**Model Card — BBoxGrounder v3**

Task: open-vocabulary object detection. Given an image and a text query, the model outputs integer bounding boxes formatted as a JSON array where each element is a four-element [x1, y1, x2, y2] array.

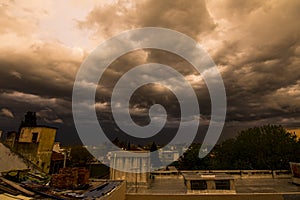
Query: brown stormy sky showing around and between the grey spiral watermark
[[0, 0, 300, 143]]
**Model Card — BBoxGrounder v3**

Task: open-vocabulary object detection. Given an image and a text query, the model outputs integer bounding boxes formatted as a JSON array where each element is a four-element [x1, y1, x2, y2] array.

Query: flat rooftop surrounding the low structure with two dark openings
[[127, 172, 300, 196]]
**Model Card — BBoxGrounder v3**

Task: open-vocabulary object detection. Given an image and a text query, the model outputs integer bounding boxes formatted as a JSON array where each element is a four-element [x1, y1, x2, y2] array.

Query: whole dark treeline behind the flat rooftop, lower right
[[172, 125, 300, 170]]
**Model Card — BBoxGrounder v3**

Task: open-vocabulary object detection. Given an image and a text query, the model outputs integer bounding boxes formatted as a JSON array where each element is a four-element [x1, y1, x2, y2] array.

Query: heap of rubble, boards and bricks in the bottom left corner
[[0, 167, 125, 200]]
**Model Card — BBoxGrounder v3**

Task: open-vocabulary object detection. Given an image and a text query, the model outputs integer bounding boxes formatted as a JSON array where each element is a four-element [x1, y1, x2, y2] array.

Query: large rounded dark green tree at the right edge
[[214, 125, 300, 170]]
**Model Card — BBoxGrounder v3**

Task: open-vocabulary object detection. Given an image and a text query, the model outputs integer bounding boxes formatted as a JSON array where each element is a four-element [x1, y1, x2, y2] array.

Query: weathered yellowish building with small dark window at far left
[[5, 126, 56, 173]]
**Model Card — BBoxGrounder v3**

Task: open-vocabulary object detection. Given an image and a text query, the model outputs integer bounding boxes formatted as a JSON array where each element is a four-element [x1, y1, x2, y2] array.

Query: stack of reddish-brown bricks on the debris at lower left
[[51, 168, 90, 189]]
